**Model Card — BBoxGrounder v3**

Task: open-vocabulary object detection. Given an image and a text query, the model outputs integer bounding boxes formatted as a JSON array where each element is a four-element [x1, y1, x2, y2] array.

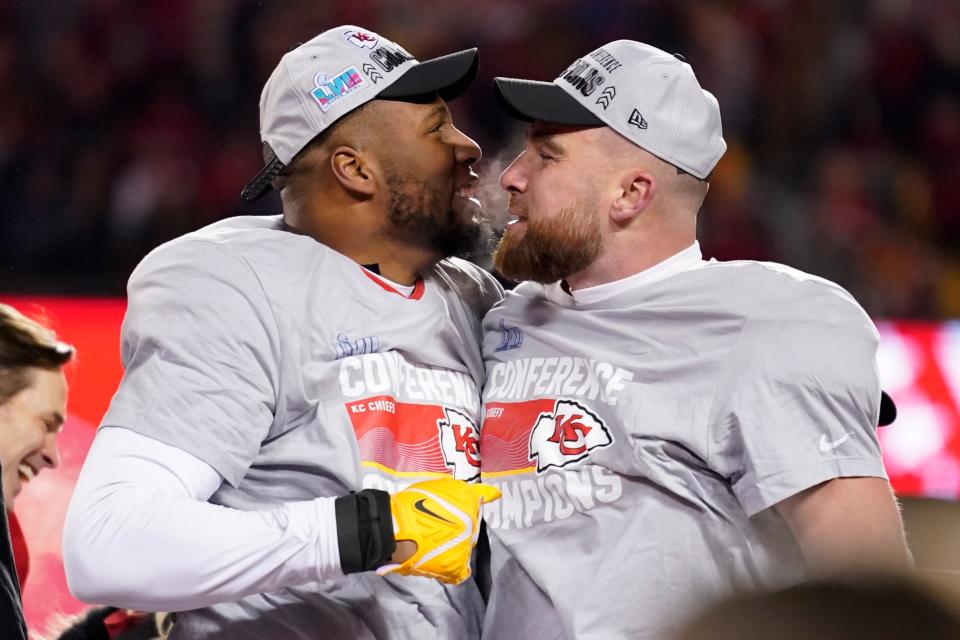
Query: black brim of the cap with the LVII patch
[[377, 48, 480, 100]]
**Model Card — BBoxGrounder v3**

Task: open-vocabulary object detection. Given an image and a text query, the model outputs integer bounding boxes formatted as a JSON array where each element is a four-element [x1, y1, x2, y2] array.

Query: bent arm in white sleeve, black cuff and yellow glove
[[63, 427, 499, 611]]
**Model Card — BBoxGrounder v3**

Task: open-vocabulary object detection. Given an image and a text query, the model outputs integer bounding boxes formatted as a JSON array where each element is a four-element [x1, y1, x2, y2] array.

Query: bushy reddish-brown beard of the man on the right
[[493, 202, 603, 284]]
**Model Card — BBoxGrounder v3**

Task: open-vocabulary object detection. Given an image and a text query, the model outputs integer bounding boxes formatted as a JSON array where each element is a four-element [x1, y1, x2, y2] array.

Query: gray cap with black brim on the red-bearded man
[[494, 40, 727, 179]]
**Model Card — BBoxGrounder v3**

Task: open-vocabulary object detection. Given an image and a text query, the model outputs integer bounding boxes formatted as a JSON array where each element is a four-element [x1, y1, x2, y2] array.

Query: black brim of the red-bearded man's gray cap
[[493, 78, 606, 127]]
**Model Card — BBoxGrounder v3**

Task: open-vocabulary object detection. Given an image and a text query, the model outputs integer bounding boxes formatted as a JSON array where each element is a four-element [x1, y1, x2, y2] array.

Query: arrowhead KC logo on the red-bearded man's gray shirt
[[530, 400, 613, 471]]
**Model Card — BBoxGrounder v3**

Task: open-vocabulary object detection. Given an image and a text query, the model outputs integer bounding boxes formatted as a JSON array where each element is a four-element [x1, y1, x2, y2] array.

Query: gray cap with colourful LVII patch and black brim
[[240, 25, 479, 201]]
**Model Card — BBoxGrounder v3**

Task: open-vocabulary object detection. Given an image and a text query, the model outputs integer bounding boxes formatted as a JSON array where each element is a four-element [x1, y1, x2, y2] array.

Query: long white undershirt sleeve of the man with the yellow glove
[[63, 427, 343, 611]]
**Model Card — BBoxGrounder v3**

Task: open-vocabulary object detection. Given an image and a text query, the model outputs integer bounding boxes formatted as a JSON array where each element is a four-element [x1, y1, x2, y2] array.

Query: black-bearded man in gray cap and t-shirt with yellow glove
[[64, 26, 502, 639]]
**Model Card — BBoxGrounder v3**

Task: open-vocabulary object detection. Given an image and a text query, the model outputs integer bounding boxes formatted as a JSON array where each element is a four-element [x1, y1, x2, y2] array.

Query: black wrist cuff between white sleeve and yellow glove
[[334, 489, 397, 573]]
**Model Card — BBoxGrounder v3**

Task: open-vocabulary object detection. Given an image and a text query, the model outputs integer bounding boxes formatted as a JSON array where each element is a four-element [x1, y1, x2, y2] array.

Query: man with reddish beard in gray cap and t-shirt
[[481, 40, 909, 639]]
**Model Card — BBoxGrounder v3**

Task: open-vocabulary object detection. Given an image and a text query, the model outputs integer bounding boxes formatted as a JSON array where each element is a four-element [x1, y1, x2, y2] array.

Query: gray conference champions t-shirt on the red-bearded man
[[481, 258, 885, 640]]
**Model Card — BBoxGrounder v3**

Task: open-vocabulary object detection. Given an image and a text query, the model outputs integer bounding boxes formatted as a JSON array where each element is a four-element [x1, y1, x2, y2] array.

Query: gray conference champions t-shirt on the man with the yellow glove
[[102, 217, 503, 640]]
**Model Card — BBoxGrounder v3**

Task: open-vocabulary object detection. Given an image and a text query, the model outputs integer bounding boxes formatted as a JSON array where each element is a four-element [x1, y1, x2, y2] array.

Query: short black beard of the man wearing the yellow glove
[[387, 173, 493, 259]]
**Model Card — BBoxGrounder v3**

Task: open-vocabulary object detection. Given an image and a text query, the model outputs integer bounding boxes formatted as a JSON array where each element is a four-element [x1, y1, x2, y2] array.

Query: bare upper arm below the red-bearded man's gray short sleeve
[[775, 477, 913, 573]]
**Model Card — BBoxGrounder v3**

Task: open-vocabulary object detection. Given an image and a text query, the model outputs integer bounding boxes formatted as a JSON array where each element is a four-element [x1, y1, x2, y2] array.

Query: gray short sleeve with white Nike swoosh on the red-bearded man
[[709, 274, 886, 516]]
